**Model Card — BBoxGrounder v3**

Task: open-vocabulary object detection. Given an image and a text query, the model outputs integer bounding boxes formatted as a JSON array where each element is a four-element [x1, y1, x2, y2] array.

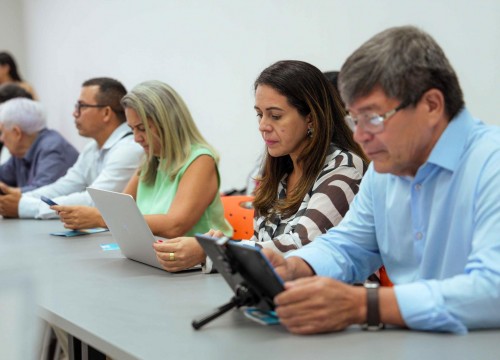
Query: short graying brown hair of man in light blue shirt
[[339, 26, 464, 119]]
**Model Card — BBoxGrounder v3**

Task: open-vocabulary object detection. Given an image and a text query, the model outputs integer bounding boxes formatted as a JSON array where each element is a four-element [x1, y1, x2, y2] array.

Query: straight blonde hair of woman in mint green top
[[121, 80, 219, 184]]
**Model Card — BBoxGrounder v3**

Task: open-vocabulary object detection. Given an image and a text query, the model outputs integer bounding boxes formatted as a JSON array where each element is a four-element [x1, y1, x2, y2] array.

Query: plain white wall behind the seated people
[[8, 0, 500, 189]]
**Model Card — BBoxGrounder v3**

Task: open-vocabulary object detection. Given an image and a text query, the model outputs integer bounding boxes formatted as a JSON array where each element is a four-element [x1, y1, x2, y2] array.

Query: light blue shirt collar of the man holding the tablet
[[427, 108, 477, 171]]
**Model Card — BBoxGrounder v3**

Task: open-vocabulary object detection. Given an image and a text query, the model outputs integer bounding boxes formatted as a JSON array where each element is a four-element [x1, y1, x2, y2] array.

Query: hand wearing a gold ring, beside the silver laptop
[[153, 237, 205, 272]]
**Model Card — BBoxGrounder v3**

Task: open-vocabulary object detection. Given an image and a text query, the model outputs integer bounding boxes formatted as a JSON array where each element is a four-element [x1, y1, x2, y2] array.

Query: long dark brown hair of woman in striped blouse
[[254, 60, 368, 217]]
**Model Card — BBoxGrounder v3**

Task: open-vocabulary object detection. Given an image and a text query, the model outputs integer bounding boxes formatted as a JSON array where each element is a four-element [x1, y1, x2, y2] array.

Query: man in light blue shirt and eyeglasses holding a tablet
[[264, 26, 500, 334]]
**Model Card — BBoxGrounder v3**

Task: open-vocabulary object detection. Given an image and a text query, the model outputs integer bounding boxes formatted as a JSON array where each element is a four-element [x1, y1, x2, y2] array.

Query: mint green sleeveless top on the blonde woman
[[136, 145, 233, 236]]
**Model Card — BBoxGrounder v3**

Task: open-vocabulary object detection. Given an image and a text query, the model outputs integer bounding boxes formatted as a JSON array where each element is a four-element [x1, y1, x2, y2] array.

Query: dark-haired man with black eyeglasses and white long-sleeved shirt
[[0, 78, 143, 219]]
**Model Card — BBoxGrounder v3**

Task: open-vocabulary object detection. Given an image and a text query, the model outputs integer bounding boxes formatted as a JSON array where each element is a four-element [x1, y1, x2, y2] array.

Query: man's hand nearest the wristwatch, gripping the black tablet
[[274, 276, 366, 334]]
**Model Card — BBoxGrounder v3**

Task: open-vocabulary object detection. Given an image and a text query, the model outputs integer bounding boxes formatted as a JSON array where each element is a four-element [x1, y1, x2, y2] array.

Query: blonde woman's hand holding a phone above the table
[[50, 205, 106, 230]]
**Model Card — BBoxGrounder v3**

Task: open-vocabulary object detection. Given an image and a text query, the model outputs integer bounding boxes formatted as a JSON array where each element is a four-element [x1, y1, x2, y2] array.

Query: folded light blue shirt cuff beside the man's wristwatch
[[394, 280, 467, 334]]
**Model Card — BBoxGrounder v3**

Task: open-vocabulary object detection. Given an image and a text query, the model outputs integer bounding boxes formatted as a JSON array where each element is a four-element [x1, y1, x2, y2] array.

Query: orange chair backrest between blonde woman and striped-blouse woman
[[221, 195, 254, 240]]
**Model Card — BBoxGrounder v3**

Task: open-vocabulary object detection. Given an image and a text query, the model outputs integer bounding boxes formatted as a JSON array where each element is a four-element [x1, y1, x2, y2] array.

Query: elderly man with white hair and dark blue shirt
[[0, 98, 78, 193]]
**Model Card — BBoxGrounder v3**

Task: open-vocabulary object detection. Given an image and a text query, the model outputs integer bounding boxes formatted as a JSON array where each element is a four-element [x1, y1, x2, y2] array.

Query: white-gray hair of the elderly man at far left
[[0, 98, 47, 135]]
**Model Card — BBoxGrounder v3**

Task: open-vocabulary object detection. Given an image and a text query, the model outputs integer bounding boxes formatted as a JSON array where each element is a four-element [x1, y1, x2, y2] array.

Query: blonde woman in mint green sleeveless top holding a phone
[[55, 81, 232, 256]]
